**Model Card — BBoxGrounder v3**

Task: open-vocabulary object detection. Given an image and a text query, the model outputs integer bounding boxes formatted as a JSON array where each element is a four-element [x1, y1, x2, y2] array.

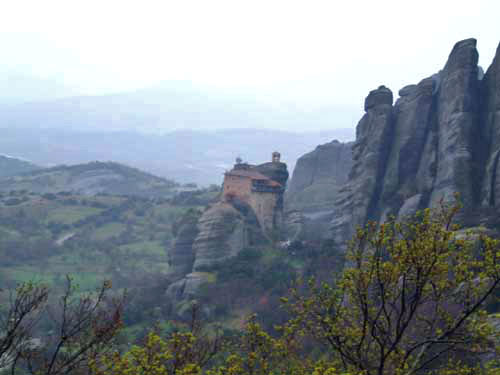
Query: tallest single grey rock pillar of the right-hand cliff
[[429, 39, 481, 210]]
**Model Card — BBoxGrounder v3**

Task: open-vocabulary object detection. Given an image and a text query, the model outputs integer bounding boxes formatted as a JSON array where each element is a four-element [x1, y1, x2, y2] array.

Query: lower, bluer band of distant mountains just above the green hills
[[0, 127, 354, 185]]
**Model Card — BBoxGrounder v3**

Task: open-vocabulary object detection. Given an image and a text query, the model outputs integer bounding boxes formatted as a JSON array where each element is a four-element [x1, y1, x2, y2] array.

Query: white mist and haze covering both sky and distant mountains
[[0, 0, 500, 184]]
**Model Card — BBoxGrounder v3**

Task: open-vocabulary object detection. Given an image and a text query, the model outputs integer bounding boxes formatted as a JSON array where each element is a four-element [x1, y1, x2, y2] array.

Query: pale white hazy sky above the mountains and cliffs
[[0, 0, 500, 108]]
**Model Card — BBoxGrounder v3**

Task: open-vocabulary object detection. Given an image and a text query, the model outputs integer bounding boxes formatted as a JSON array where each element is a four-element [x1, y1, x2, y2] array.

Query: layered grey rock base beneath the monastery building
[[166, 199, 267, 311]]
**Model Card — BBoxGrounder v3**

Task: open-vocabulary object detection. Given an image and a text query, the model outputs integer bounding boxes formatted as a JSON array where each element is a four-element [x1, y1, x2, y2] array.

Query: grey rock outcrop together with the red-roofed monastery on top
[[167, 153, 288, 313]]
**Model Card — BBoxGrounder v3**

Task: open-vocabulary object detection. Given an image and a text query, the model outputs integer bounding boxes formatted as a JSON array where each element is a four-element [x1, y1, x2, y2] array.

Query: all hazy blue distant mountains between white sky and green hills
[[0, 82, 357, 185]]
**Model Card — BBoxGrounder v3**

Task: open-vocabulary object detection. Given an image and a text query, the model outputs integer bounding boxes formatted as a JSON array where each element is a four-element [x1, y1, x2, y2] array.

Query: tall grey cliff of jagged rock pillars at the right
[[287, 39, 500, 248]]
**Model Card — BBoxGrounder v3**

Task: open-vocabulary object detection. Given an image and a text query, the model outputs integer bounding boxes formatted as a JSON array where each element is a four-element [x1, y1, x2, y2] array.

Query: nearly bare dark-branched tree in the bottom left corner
[[0, 276, 124, 375]]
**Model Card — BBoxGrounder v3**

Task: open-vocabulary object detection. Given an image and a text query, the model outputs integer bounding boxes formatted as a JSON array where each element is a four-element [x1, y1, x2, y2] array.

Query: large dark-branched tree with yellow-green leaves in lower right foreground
[[285, 204, 500, 375]]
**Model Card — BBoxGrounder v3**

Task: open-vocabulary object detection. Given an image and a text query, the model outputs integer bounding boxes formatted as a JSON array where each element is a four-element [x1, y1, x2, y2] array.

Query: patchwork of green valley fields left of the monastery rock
[[0, 192, 190, 290]]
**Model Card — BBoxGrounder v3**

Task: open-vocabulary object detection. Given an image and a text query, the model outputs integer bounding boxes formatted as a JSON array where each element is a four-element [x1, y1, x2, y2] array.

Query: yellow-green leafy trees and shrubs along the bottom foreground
[[91, 201, 500, 375]]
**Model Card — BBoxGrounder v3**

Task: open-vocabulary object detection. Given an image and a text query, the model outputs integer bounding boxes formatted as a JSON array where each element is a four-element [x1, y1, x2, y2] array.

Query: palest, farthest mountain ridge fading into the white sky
[[0, 77, 358, 132]]
